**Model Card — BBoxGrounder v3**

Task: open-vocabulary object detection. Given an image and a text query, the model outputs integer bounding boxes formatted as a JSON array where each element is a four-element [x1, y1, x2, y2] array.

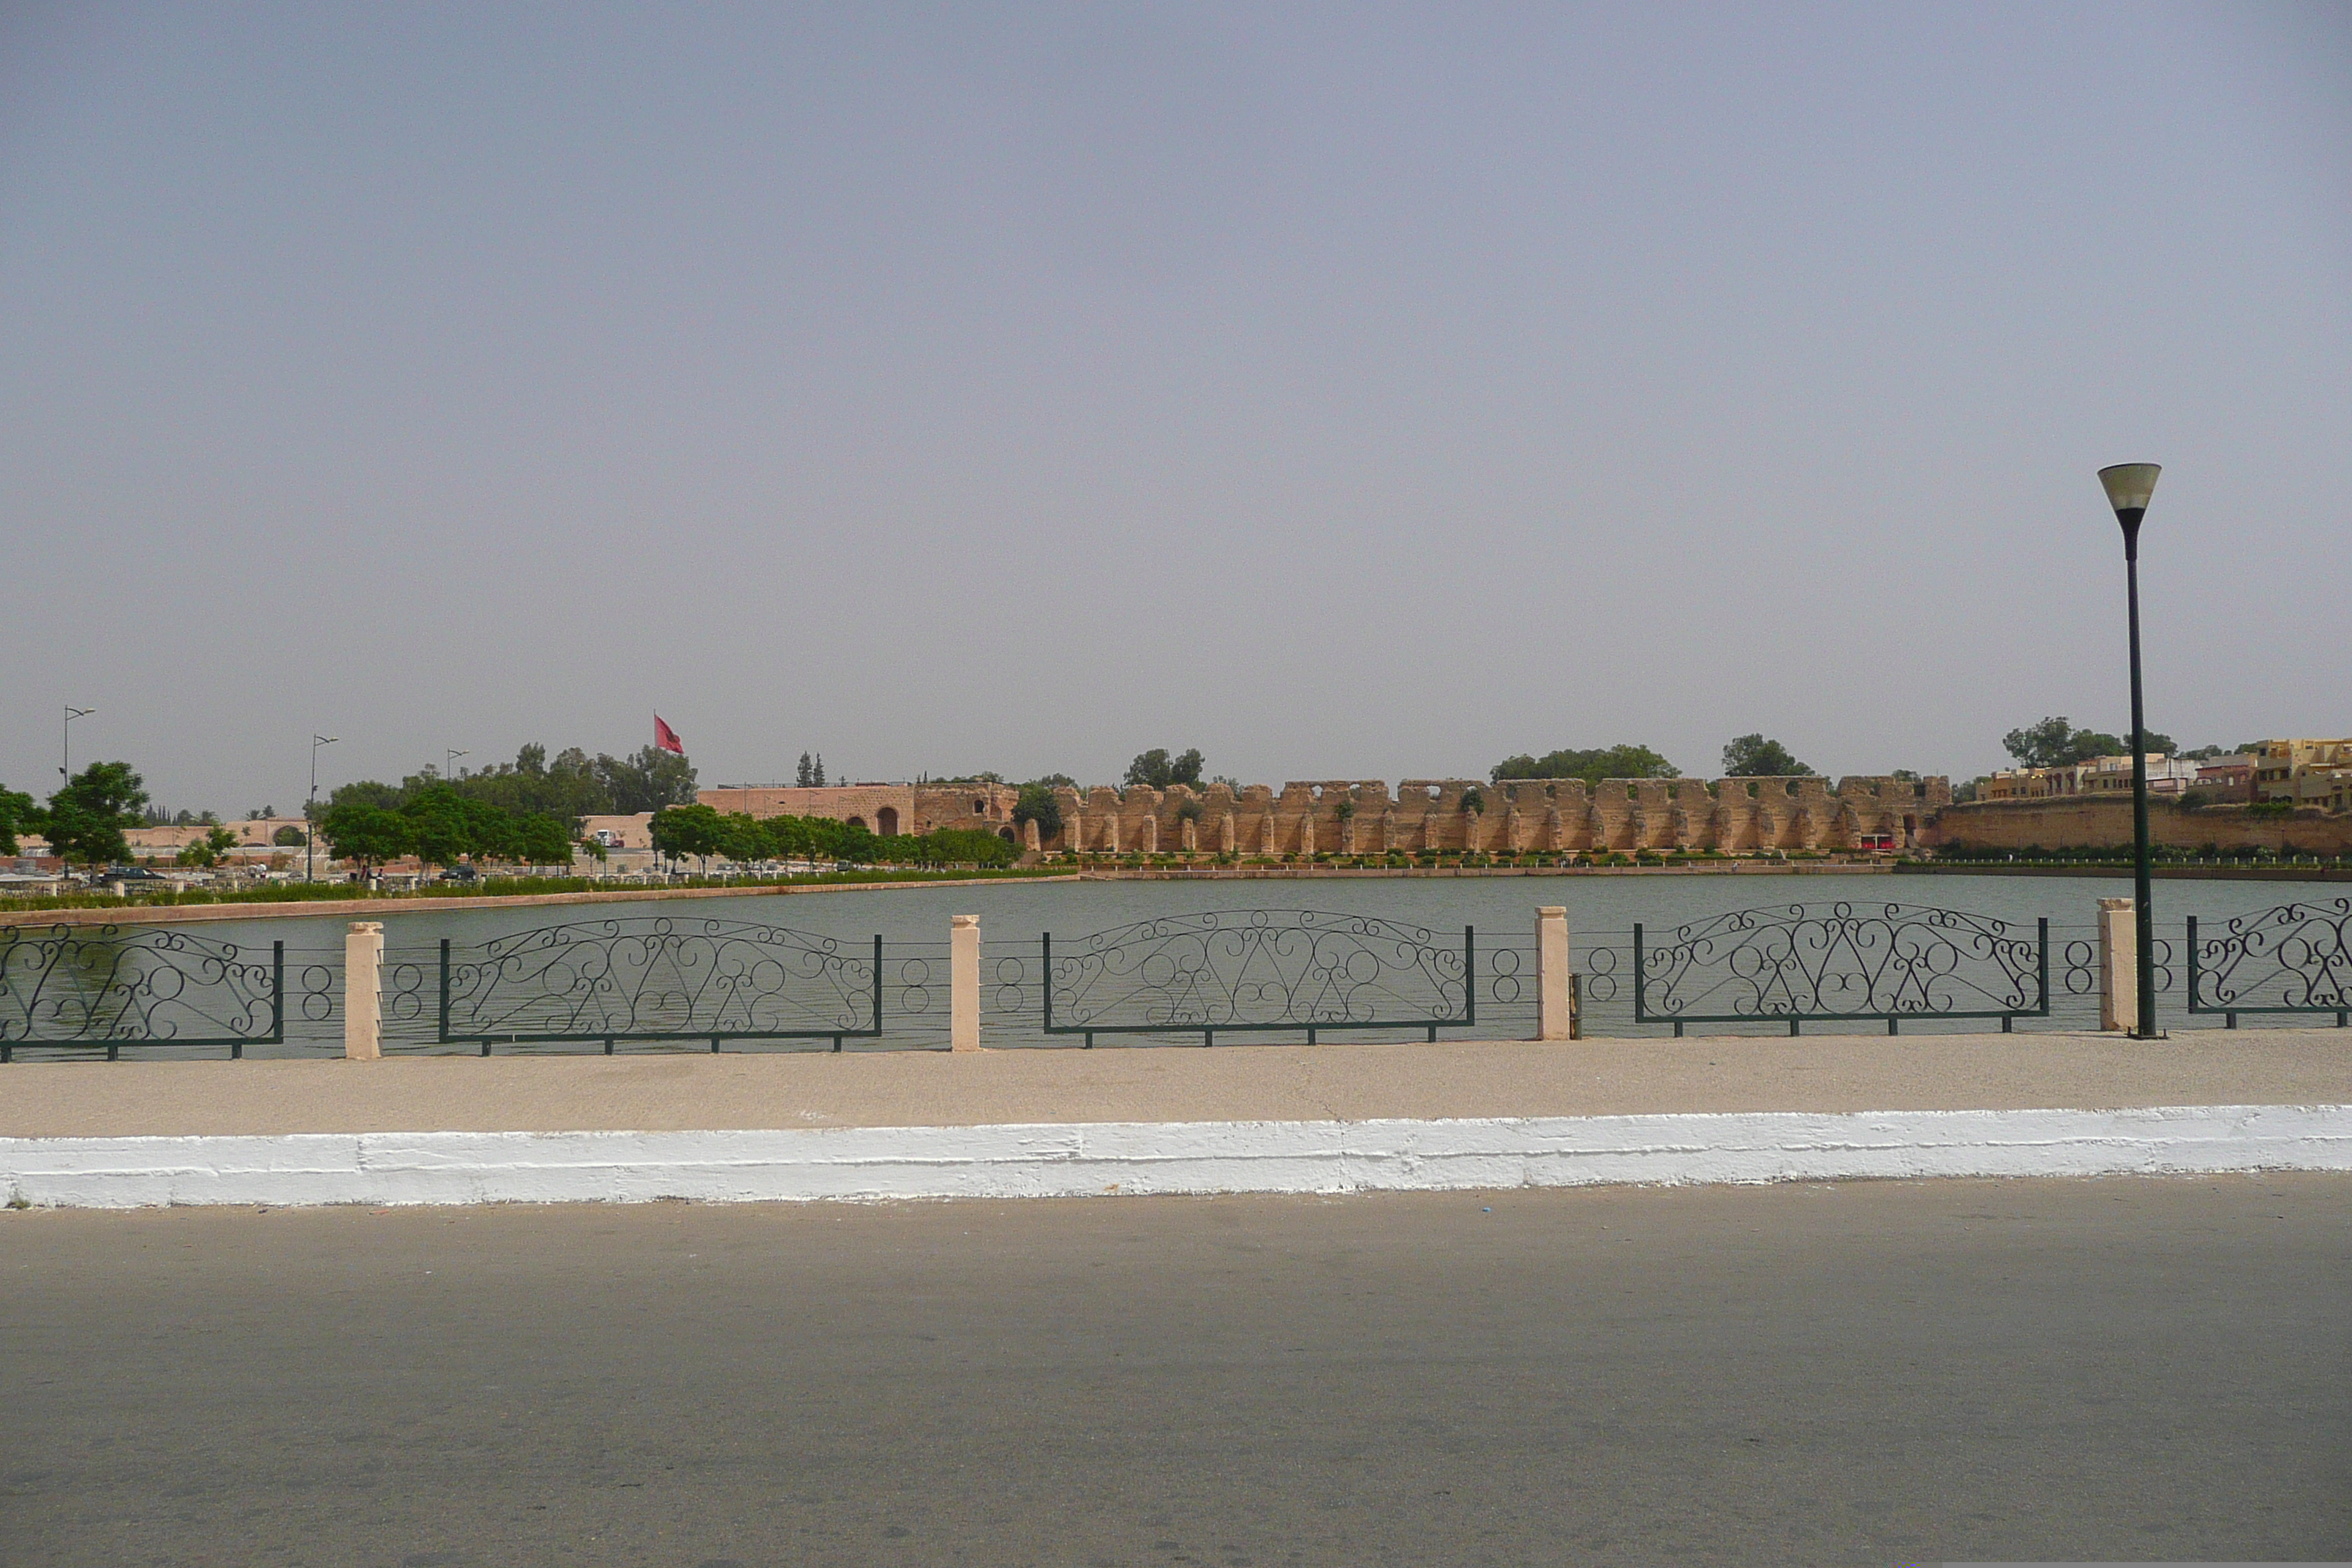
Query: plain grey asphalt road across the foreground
[[0, 1175, 2352, 1568]]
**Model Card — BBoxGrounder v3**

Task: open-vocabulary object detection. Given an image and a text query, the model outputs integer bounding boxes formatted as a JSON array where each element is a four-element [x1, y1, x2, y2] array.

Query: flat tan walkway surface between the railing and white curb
[[0, 1030, 2352, 1138]]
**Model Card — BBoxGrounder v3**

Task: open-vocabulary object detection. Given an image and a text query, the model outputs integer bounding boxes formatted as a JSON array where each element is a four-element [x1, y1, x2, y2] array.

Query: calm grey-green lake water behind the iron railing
[[19, 875, 2348, 1060]]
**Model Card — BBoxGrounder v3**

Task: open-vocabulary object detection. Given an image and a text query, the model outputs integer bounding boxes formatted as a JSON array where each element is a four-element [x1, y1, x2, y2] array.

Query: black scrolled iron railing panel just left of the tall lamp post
[[1632, 902, 2051, 1034]]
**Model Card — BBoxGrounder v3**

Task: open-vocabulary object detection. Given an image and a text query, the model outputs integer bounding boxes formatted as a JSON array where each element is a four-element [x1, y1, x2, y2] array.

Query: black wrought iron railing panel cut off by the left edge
[[0, 924, 287, 1063]]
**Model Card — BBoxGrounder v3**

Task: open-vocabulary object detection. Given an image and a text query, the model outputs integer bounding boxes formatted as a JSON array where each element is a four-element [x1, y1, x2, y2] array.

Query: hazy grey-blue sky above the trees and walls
[[0, 0, 2352, 813]]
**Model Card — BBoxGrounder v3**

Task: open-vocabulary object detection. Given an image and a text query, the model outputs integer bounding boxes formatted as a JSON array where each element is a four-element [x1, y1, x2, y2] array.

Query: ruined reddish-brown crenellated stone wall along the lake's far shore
[[1039, 778, 1952, 856]]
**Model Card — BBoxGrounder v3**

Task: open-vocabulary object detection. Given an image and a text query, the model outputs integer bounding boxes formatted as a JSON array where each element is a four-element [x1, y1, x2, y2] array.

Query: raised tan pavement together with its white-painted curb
[[0, 1030, 2352, 1206]]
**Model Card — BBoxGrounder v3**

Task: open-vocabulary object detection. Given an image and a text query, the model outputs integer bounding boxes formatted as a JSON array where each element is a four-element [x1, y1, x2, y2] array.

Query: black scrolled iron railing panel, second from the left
[[428, 917, 884, 1055]]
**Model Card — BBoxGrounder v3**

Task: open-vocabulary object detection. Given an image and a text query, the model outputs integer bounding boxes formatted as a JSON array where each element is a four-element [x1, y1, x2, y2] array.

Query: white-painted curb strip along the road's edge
[[0, 1105, 2352, 1208]]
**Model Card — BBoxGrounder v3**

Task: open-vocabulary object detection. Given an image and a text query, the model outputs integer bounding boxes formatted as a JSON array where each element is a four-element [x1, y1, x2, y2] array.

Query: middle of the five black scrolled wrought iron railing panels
[[1039, 910, 1477, 1046]]
